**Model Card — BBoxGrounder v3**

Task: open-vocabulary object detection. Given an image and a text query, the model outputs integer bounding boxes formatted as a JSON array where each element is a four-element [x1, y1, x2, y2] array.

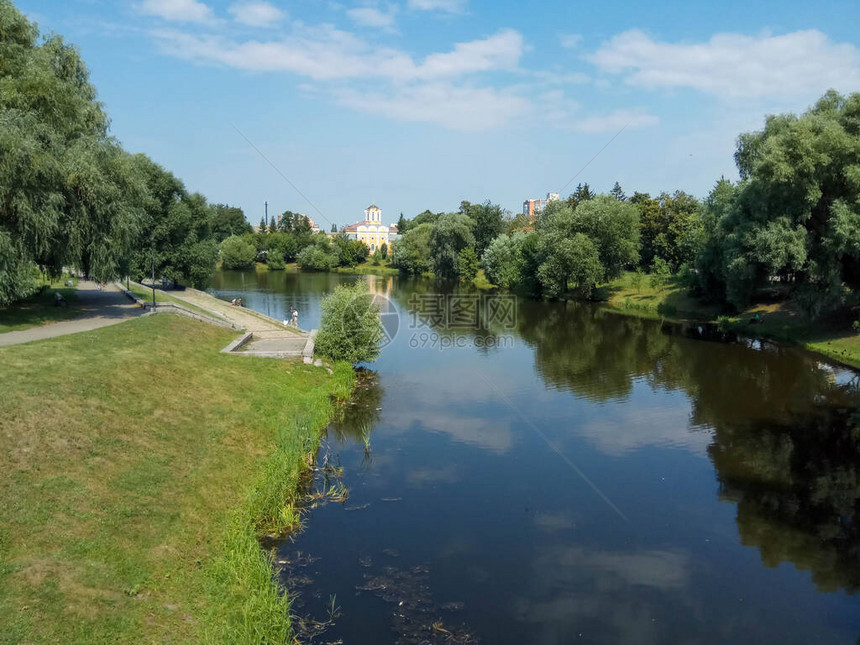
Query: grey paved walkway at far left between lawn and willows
[[0, 280, 144, 347]]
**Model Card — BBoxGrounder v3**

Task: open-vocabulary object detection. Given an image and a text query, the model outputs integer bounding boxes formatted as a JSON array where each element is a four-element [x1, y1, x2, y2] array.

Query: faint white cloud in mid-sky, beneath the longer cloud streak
[[339, 83, 529, 131]]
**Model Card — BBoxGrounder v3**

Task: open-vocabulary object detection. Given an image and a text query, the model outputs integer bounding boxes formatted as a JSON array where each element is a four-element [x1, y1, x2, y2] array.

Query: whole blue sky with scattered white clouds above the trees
[[17, 0, 860, 226]]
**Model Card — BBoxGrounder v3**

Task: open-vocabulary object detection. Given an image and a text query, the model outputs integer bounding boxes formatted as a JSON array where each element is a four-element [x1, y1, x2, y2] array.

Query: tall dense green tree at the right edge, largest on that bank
[[698, 91, 860, 315]]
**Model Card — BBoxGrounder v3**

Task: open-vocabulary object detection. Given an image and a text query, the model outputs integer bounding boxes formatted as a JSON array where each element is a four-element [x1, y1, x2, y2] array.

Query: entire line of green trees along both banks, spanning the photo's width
[[0, 0, 860, 315]]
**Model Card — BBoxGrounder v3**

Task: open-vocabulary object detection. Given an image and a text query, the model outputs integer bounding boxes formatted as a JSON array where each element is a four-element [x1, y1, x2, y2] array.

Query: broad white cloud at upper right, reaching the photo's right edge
[[590, 30, 860, 98]]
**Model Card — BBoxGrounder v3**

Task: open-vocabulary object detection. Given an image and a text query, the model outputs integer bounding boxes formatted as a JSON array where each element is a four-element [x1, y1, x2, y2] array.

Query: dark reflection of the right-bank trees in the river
[[518, 301, 860, 593]]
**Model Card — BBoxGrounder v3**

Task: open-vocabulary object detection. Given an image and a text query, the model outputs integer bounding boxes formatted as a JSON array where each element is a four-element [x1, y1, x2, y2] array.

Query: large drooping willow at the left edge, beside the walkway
[[0, 0, 146, 304]]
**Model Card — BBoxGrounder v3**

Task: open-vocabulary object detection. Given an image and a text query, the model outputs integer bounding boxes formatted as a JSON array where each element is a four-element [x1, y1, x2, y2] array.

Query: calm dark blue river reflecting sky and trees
[[213, 271, 860, 645]]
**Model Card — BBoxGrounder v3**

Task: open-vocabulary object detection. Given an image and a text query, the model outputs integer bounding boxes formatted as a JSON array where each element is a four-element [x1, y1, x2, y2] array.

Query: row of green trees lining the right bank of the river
[[456, 91, 860, 316]]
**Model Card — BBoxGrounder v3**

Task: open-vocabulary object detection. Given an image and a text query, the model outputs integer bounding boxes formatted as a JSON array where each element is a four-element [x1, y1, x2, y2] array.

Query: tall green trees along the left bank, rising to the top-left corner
[[0, 0, 250, 305]]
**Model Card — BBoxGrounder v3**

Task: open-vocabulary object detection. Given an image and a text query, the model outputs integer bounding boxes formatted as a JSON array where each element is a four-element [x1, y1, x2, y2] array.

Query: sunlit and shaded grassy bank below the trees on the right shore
[[597, 273, 860, 368]]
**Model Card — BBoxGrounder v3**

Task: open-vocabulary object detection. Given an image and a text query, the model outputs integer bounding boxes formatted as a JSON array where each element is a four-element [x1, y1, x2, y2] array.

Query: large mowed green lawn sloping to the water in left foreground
[[0, 315, 352, 645]]
